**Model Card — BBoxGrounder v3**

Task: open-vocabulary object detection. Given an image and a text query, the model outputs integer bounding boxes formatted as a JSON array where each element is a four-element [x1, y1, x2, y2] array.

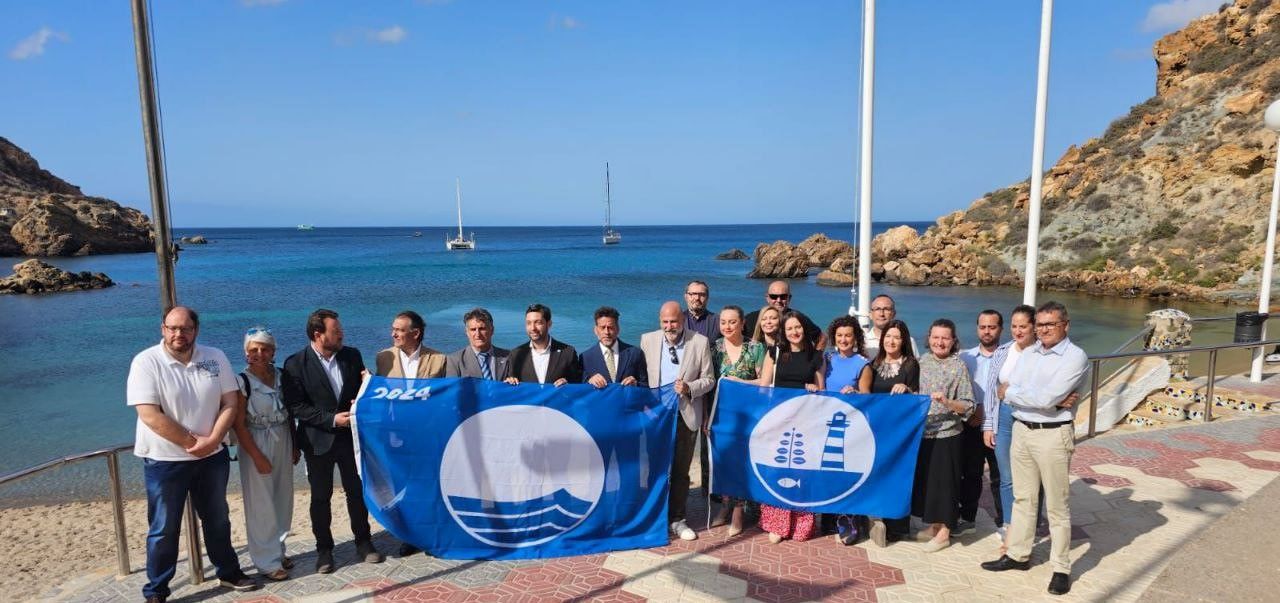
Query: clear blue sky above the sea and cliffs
[[0, 0, 1220, 227]]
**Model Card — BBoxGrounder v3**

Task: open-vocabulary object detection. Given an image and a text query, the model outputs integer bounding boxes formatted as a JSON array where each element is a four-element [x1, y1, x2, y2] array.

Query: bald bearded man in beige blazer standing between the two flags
[[640, 301, 716, 540]]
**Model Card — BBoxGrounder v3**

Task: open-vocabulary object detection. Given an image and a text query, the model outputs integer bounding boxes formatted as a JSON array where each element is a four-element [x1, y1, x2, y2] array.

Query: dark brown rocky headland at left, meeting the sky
[[0, 137, 155, 256]]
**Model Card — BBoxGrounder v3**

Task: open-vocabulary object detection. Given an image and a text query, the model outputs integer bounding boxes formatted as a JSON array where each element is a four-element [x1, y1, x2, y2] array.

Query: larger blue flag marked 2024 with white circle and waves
[[345, 376, 676, 559]]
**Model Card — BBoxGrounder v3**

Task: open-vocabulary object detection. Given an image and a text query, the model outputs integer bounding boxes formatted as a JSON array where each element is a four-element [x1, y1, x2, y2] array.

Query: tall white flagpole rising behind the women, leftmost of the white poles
[[850, 0, 876, 326]]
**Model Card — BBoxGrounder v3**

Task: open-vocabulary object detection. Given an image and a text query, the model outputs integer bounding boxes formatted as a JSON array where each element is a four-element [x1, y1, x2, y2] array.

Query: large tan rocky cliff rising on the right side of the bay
[[758, 0, 1280, 301]]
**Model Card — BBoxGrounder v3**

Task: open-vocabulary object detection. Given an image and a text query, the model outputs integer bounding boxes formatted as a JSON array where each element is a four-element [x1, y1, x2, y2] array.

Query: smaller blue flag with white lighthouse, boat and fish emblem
[[712, 380, 929, 517]]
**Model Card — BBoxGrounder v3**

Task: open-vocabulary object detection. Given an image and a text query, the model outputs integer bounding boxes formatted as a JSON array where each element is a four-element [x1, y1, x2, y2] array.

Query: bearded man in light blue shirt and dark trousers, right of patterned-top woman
[[956, 309, 1005, 534]]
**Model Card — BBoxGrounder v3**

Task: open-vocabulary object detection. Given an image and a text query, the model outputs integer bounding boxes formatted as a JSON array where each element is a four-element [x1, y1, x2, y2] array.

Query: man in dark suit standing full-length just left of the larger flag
[[280, 309, 383, 574]]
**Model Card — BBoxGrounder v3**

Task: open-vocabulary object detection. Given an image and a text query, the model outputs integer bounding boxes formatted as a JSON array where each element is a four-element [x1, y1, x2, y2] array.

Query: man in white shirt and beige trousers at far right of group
[[982, 301, 1089, 594]]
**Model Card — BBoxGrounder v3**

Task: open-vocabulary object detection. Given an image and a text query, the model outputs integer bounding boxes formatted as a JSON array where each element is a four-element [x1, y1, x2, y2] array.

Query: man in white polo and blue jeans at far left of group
[[125, 306, 257, 602]]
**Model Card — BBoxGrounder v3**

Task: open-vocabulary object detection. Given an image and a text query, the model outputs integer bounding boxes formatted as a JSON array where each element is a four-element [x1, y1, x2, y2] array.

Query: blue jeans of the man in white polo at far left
[[142, 449, 241, 598]]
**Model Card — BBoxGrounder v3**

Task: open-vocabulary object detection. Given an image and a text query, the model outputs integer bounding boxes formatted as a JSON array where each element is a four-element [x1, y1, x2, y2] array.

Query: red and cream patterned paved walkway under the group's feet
[[42, 416, 1280, 603]]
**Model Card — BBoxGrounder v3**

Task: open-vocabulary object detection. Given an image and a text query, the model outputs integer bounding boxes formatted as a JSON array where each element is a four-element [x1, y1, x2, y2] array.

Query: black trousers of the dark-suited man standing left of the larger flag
[[306, 429, 372, 551]]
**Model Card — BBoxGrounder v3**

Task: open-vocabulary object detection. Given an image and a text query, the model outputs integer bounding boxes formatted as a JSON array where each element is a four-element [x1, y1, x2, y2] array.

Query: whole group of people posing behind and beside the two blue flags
[[127, 280, 1088, 602]]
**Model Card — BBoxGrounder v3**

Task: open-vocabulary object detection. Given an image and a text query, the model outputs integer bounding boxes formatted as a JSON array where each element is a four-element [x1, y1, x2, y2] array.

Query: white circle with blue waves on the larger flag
[[440, 405, 604, 548]]
